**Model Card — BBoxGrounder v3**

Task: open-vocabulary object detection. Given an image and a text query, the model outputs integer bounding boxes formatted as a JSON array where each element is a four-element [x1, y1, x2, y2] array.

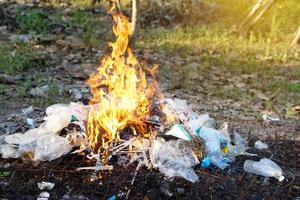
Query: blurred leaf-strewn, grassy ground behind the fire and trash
[[0, 0, 300, 120]]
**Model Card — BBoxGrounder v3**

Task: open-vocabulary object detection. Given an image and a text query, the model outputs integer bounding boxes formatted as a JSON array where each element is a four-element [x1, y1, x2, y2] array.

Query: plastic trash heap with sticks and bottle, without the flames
[[0, 98, 284, 183]]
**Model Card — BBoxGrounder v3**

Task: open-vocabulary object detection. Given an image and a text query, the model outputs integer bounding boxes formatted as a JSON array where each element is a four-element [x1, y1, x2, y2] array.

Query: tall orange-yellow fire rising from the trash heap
[[87, 9, 156, 149]]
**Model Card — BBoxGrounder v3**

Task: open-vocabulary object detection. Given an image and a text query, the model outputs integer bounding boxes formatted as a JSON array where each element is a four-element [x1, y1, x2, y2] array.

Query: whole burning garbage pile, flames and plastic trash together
[[0, 8, 284, 182]]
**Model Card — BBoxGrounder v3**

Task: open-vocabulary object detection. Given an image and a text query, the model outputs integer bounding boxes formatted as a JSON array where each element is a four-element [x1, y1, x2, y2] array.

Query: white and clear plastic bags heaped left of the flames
[[0, 103, 88, 161]]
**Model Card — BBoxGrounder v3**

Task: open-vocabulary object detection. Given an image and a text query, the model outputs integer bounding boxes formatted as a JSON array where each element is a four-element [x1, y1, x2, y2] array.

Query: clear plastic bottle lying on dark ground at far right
[[244, 158, 284, 181]]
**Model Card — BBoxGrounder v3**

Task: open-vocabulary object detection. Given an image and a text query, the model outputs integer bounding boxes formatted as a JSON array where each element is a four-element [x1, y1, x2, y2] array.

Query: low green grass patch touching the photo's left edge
[[0, 42, 39, 74]]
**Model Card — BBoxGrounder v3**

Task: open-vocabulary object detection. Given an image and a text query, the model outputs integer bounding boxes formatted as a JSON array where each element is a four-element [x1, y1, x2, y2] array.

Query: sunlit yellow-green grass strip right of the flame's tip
[[137, 24, 300, 76]]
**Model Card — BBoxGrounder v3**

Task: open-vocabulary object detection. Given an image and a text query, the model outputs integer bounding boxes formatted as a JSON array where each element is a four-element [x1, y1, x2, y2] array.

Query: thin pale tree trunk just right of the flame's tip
[[129, 0, 140, 47]]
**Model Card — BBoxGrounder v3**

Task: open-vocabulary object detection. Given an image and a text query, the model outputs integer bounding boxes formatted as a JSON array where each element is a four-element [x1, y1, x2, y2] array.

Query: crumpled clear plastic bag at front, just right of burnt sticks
[[149, 139, 199, 183]]
